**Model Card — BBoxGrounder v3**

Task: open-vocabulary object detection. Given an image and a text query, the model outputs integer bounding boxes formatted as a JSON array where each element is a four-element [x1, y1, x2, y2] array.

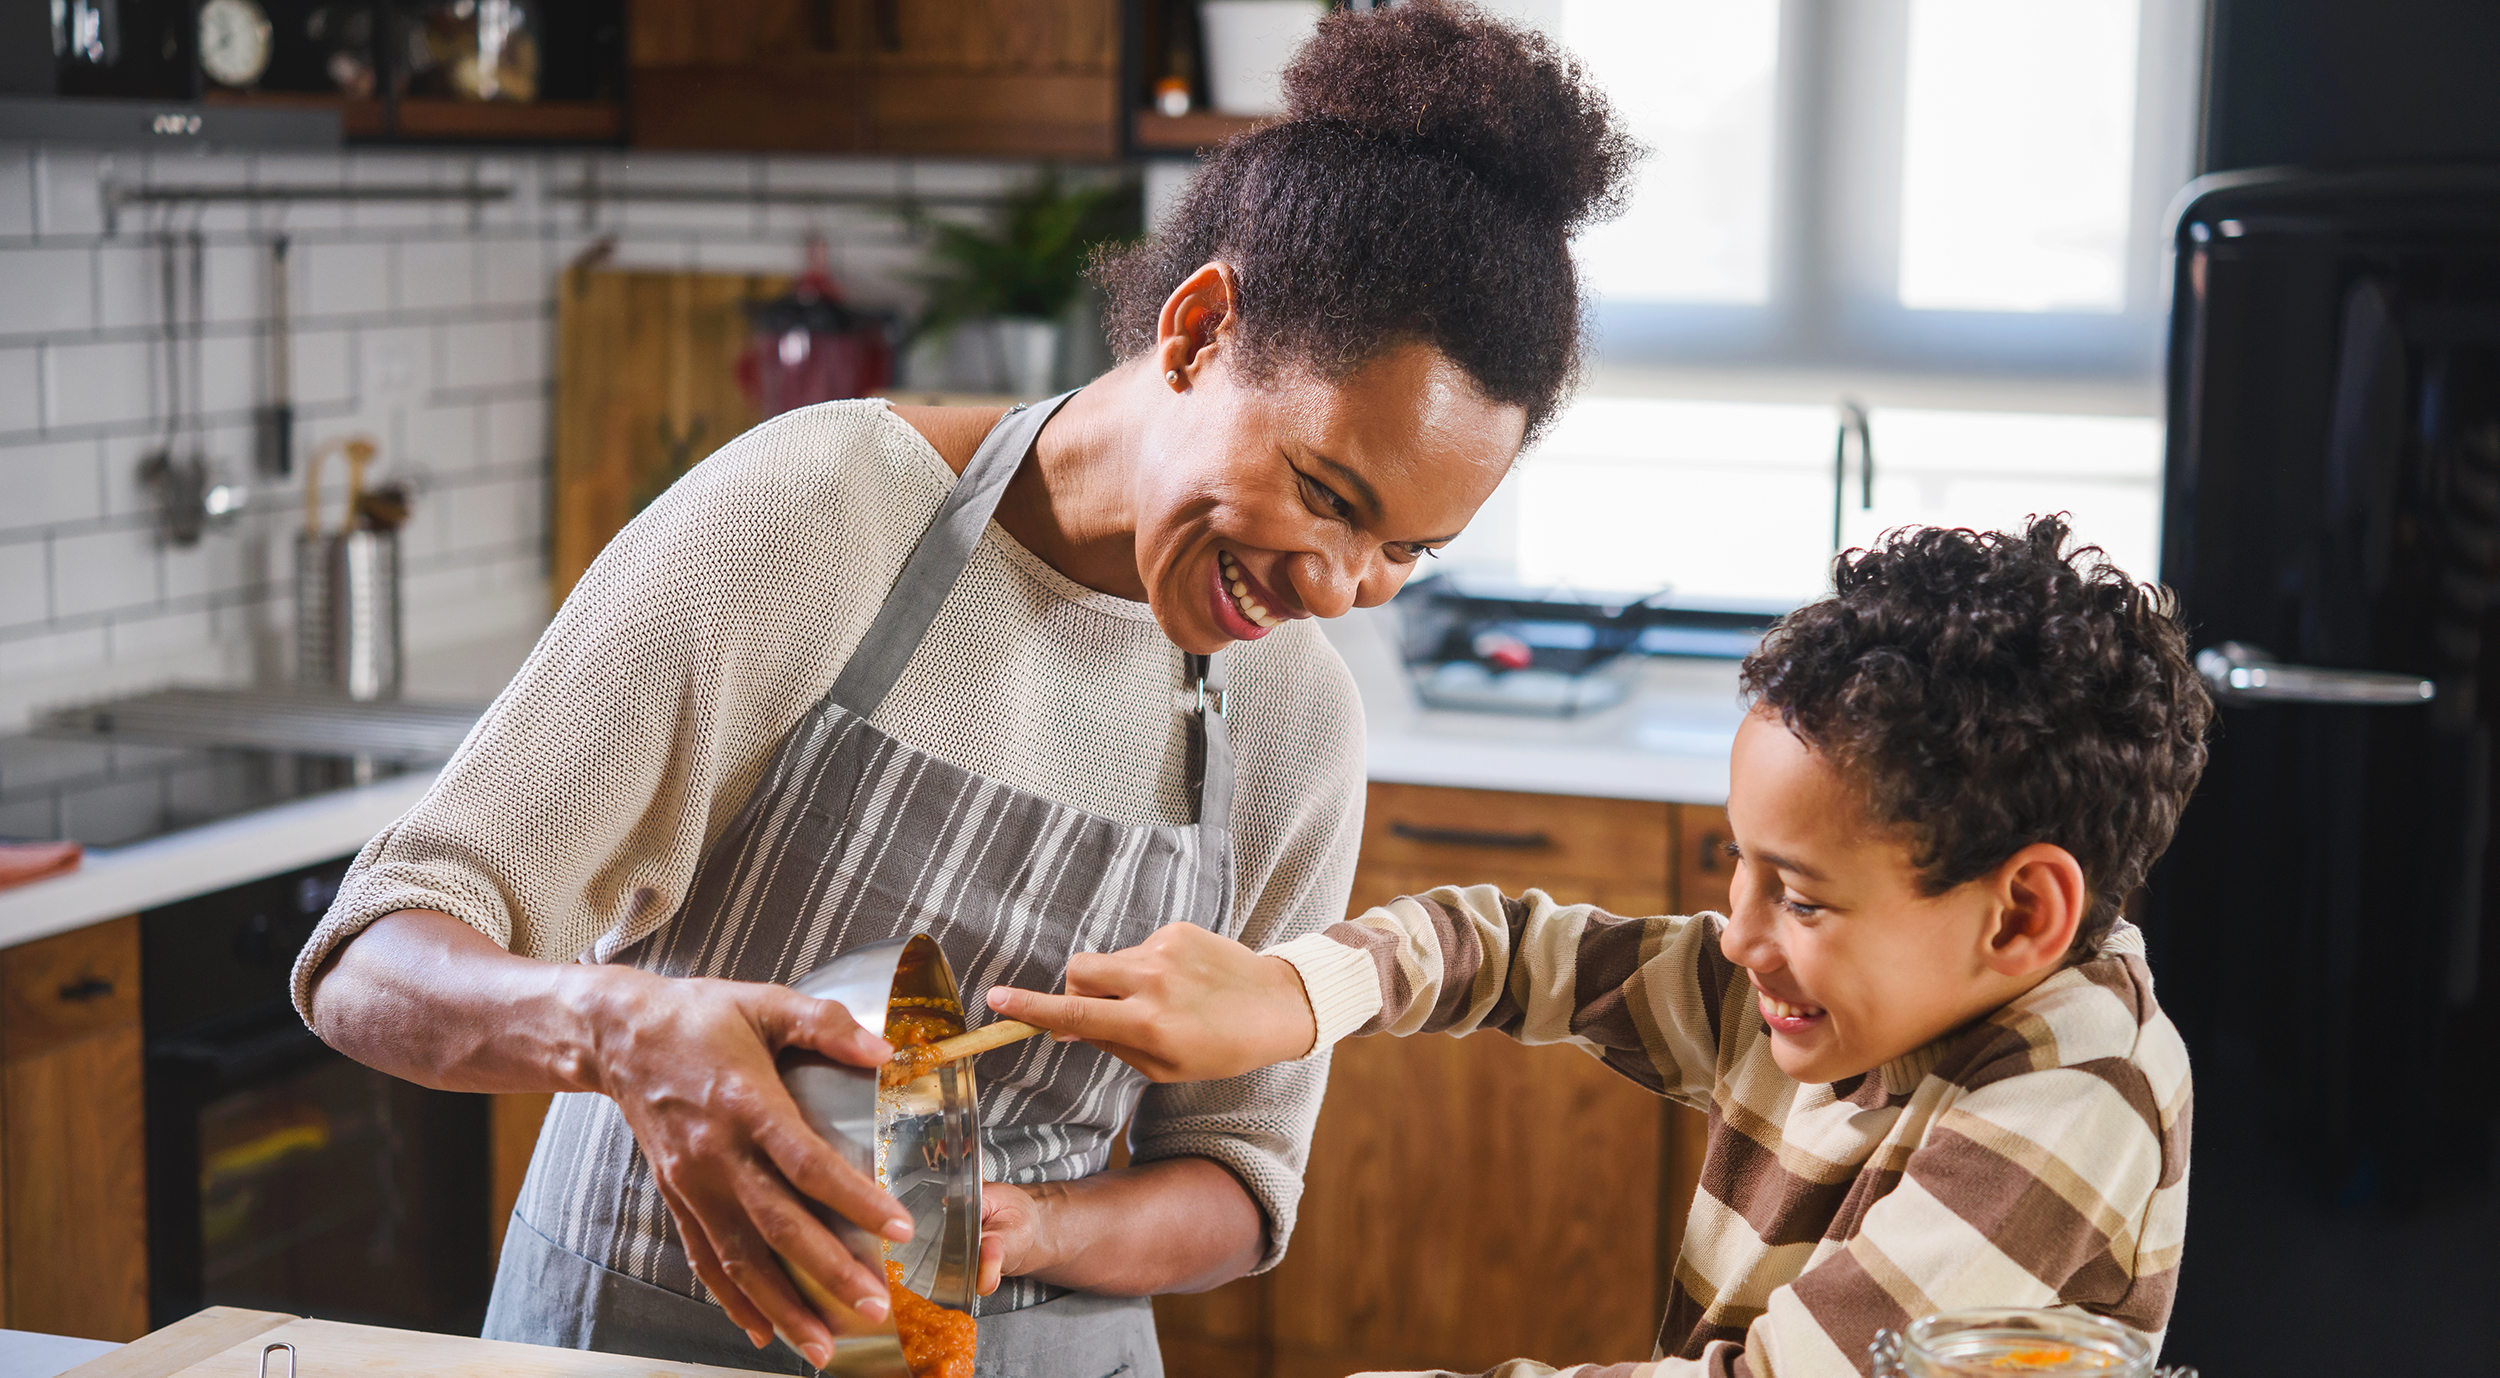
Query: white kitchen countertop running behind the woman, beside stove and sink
[[0, 610, 1743, 948]]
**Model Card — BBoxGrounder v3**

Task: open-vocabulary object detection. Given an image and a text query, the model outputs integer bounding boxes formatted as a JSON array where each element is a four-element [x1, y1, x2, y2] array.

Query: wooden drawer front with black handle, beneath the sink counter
[[1363, 783, 1673, 890]]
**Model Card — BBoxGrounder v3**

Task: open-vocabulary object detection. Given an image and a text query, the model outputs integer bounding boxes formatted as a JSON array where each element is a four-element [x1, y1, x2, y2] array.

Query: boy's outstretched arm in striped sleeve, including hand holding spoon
[[990, 885, 1735, 1100]]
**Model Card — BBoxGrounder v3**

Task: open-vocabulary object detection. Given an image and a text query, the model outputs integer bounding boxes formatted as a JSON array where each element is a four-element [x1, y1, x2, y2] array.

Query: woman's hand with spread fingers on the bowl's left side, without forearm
[[590, 968, 913, 1368]]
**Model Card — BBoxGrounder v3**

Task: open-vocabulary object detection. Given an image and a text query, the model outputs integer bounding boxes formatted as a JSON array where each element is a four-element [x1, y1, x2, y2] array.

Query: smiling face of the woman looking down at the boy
[[1133, 345, 1528, 655]]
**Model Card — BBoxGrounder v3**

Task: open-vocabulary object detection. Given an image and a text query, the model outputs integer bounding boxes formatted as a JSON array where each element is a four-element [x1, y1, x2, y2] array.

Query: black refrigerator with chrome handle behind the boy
[[2143, 168, 2500, 1378]]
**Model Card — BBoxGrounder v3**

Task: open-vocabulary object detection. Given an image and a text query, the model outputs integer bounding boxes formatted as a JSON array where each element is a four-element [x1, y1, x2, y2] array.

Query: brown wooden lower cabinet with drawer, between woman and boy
[[1155, 783, 1728, 1378]]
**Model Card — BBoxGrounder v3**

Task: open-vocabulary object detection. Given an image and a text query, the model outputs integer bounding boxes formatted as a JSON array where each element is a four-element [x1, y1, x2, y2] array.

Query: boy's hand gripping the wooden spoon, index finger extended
[[990, 923, 1320, 1080]]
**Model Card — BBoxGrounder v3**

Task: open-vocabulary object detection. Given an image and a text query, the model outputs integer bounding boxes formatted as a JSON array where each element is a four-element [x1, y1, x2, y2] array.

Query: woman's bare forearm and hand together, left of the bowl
[[310, 910, 910, 1368]]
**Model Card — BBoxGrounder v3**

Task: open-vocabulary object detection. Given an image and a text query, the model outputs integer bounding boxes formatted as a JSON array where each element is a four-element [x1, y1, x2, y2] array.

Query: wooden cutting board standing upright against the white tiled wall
[[550, 265, 790, 603]]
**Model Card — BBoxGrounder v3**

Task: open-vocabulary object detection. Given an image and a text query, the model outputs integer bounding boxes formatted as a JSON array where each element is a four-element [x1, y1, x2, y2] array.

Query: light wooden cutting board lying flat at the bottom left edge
[[63, 1305, 780, 1378]]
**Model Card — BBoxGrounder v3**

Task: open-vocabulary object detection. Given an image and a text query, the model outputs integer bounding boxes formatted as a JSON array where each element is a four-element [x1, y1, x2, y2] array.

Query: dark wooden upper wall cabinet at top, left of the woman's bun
[[628, 0, 1120, 160]]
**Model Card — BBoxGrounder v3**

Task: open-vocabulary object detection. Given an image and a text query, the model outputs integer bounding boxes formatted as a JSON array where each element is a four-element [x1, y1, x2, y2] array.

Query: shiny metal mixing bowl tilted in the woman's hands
[[780, 933, 980, 1378]]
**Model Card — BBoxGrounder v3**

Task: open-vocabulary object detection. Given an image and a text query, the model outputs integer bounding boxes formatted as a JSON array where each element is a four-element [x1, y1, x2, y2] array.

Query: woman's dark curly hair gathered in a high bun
[[1093, 0, 1640, 438]]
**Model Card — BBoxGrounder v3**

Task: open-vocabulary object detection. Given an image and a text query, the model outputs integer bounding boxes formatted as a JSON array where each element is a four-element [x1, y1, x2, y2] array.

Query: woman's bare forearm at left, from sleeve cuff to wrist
[[310, 910, 625, 1090]]
